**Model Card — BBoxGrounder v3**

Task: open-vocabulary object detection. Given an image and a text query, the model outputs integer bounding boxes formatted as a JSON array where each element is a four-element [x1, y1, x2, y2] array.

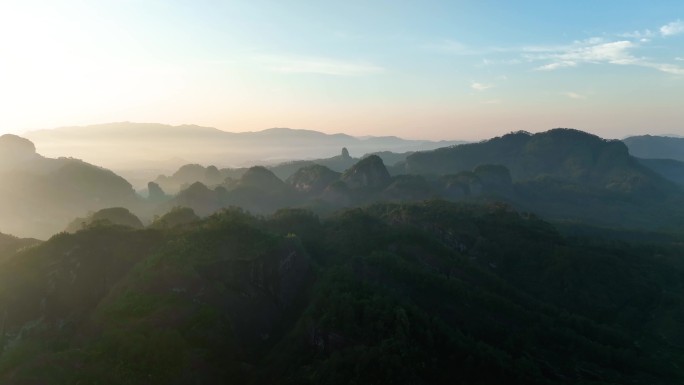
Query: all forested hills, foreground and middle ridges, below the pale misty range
[[0, 129, 684, 385]]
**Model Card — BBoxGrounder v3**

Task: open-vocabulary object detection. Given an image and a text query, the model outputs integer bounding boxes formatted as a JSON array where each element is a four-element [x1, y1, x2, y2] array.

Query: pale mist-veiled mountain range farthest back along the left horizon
[[25, 122, 462, 183]]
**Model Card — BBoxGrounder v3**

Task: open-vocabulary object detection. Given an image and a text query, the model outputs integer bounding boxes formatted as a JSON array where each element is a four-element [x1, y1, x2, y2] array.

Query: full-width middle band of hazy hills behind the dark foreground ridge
[[5, 129, 684, 238]]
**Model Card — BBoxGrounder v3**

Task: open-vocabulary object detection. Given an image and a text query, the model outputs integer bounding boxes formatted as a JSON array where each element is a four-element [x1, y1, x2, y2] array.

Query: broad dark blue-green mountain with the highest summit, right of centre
[[405, 129, 672, 191]]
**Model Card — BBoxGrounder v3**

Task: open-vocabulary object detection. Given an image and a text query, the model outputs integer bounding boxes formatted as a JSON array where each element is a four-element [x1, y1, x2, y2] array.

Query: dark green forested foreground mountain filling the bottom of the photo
[[0, 201, 684, 385]]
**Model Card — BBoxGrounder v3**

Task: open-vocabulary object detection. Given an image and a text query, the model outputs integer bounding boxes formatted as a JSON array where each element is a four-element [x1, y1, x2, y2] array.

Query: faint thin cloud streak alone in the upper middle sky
[[254, 55, 385, 76]]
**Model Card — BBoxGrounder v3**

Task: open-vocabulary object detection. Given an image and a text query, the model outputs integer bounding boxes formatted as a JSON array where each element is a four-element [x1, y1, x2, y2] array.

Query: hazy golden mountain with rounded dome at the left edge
[[0, 135, 139, 238]]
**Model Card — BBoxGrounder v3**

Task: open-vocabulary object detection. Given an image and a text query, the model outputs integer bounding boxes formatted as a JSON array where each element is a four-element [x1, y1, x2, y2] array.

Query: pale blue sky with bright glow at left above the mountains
[[0, 0, 684, 140]]
